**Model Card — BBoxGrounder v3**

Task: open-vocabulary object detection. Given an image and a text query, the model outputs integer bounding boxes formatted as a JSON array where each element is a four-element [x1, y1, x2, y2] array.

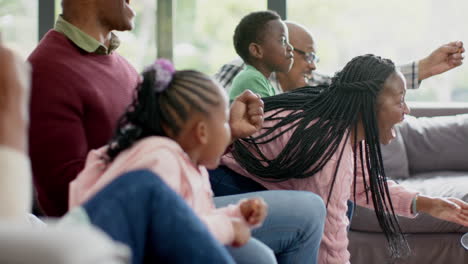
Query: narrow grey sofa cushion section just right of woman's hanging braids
[[381, 125, 409, 179]]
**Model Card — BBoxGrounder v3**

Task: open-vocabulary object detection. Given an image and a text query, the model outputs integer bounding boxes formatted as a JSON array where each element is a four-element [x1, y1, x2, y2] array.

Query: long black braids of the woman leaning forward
[[232, 54, 409, 257]]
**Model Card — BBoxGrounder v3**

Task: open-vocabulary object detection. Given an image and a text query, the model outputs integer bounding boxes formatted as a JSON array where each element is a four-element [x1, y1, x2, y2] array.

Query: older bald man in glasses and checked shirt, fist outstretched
[[215, 21, 465, 95]]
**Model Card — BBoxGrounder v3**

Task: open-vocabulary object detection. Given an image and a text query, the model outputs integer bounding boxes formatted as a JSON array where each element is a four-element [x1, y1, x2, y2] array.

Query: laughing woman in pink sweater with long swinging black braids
[[222, 55, 468, 263]]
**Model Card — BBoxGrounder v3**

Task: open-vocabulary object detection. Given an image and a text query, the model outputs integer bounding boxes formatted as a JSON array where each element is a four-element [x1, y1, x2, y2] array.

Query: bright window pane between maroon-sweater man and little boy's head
[[174, 0, 267, 75]]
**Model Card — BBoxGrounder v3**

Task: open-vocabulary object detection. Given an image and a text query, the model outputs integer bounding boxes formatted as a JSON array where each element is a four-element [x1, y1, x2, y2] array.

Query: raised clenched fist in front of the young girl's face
[[229, 90, 263, 141]]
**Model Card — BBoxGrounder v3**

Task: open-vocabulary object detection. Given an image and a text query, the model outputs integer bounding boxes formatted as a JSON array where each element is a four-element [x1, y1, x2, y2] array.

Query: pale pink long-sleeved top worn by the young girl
[[69, 136, 247, 245]]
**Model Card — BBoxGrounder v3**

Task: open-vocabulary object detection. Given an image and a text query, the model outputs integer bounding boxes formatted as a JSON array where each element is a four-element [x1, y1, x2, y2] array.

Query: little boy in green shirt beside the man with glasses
[[229, 11, 293, 100]]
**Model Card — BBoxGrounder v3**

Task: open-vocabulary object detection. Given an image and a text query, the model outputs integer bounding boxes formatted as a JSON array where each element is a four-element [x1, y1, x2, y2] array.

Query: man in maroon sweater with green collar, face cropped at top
[[28, 0, 139, 216]]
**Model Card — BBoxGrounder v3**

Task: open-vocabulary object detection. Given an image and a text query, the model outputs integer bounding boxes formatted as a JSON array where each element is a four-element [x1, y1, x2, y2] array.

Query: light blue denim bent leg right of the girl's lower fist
[[215, 191, 326, 263]]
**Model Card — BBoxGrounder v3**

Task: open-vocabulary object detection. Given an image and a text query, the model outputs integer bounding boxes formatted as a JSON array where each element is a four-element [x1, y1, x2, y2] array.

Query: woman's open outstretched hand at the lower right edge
[[416, 195, 468, 226]]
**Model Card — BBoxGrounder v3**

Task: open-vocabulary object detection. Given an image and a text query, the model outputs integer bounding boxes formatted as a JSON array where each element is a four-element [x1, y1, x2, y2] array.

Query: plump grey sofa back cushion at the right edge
[[400, 114, 468, 174]]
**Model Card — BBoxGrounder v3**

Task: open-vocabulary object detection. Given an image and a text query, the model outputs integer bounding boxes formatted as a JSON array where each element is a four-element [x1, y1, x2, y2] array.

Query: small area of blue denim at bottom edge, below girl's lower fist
[[226, 238, 277, 264]]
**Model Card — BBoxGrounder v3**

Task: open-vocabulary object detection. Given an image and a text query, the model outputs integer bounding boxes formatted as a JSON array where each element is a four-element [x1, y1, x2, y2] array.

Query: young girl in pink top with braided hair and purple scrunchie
[[69, 60, 282, 263]]
